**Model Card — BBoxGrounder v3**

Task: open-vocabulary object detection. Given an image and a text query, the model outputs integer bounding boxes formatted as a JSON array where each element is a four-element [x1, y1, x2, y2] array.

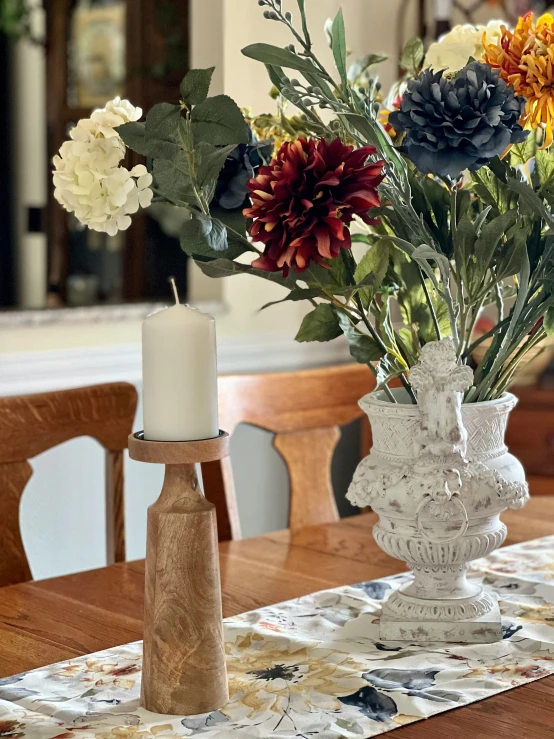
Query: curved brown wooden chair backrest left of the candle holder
[[0, 382, 137, 586]]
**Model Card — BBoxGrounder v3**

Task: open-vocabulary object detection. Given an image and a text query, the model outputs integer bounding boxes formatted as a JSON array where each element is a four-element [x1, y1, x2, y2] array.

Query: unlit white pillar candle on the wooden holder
[[142, 286, 219, 441]]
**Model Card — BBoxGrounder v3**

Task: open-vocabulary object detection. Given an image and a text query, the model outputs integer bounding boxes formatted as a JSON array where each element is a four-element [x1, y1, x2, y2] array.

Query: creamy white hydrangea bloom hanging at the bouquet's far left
[[54, 98, 152, 236]]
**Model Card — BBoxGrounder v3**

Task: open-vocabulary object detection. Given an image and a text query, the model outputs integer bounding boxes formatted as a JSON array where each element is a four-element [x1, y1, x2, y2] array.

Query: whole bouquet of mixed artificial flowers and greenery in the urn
[[54, 0, 554, 402]]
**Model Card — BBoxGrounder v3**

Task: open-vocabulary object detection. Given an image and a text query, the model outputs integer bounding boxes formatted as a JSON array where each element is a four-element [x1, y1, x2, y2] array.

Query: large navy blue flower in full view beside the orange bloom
[[389, 62, 529, 177]]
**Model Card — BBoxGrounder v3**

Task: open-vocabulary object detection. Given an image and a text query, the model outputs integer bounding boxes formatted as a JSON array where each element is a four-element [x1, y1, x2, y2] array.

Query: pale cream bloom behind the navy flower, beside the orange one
[[423, 21, 505, 74]]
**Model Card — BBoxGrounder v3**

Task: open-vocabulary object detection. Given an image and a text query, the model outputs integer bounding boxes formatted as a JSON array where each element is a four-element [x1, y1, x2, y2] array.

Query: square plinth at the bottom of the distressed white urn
[[379, 599, 502, 644]]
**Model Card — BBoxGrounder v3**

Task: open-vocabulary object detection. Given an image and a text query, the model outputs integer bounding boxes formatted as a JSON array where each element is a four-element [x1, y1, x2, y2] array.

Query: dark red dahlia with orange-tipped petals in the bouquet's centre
[[243, 138, 384, 277]]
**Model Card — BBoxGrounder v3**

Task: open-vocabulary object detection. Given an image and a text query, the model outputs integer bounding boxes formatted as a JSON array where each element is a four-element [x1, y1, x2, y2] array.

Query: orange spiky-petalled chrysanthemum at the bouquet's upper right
[[483, 13, 554, 148]]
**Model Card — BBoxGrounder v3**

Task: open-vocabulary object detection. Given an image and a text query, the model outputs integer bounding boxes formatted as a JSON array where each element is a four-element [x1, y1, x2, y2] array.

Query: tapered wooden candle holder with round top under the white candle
[[129, 431, 229, 716]]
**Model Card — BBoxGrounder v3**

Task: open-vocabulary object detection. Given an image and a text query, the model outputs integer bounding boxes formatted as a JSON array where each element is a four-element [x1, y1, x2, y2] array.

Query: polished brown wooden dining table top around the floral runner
[[0, 495, 554, 739]]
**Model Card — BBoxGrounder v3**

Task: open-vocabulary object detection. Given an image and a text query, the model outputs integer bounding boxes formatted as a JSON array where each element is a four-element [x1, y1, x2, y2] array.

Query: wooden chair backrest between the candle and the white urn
[[202, 364, 375, 541]]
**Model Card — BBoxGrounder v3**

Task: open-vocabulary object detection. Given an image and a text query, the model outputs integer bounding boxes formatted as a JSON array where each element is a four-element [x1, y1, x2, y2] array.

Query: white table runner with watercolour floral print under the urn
[[0, 536, 554, 739]]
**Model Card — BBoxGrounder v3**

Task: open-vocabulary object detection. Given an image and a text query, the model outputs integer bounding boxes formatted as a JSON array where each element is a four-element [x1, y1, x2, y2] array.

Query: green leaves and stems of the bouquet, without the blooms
[[119, 0, 554, 402]]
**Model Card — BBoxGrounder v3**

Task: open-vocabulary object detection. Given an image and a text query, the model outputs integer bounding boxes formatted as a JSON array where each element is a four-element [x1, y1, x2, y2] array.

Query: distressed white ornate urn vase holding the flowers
[[348, 339, 528, 643]]
